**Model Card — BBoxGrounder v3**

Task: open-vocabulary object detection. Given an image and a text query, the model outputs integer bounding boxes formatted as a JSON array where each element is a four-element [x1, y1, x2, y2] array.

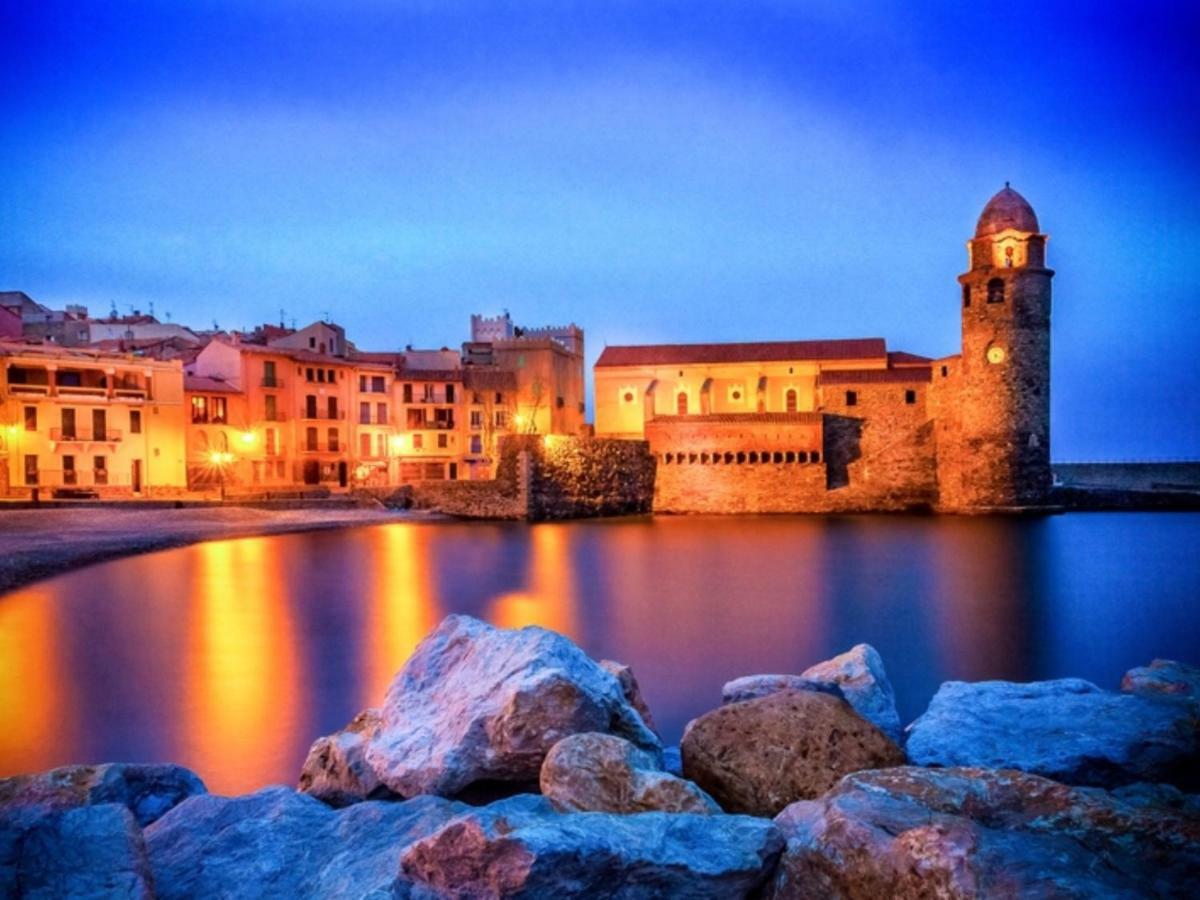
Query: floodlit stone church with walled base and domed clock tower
[[594, 185, 1054, 512]]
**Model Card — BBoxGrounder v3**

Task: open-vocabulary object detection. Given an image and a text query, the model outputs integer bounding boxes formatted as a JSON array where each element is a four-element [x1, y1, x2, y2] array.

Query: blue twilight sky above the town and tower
[[0, 0, 1200, 460]]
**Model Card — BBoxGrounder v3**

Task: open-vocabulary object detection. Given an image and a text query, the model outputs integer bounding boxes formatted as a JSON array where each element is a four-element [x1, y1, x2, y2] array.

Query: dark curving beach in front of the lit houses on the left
[[0, 506, 434, 600]]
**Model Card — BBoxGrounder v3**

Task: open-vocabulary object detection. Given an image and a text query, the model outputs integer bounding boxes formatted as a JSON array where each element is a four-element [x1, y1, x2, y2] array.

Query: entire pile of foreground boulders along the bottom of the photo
[[0, 616, 1200, 900]]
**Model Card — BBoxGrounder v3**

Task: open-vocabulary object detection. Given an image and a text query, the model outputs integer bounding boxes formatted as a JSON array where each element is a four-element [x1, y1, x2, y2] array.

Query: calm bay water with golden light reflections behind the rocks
[[0, 514, 1200, 793]]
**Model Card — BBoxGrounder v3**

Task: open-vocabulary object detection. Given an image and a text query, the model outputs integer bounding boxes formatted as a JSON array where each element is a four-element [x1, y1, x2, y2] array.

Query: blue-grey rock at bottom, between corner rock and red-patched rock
[[145, 787, 468, 900]]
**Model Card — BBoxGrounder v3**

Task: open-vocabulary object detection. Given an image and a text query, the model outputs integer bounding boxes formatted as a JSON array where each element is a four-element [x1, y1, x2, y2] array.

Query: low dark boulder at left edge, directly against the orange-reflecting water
[[0, 763, 205, 826]]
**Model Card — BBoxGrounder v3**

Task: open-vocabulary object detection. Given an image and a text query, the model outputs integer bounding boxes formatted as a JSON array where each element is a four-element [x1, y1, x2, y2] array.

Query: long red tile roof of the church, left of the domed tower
[[595, 337, 887, 368]]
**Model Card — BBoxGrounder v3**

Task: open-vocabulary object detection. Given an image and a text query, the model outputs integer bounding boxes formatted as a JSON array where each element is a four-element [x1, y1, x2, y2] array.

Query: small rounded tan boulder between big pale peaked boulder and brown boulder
[[540, 734, 721, 814]]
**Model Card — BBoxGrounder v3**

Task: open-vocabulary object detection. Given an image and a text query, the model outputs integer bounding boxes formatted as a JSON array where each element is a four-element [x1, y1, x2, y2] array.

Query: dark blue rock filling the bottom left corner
[[0, 803, 154, 900]]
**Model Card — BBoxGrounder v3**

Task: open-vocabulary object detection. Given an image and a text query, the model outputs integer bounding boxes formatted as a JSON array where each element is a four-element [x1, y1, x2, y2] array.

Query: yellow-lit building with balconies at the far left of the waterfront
[[0, 342, 186, 497]]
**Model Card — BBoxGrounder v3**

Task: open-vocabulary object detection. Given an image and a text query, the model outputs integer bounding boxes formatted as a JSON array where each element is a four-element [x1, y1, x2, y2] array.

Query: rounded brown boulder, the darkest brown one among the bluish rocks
[[679, 691, 904, 816]]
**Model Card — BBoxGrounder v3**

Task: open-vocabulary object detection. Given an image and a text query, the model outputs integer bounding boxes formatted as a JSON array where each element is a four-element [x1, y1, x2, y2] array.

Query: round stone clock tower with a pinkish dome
[[940, 182, 1054, 509]]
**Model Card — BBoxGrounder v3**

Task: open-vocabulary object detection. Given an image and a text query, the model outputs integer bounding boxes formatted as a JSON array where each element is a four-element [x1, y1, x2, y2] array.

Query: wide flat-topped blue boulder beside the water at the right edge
[[906, 678, 1200, 790]]
